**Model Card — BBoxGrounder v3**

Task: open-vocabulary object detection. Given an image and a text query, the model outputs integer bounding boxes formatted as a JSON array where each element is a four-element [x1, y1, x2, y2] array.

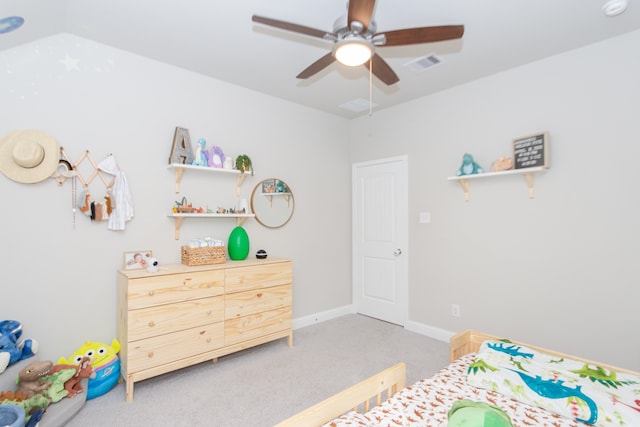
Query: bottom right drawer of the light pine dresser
[[224, 307, 291, 345]]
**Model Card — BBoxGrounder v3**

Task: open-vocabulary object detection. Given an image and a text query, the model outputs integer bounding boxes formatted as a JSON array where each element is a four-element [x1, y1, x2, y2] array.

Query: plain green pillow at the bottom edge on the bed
[[447, 399, 513, 427]]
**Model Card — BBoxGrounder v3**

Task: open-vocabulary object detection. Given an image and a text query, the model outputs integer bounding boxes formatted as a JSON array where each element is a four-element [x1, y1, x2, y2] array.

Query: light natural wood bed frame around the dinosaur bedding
[[274, 329, 640, 427]]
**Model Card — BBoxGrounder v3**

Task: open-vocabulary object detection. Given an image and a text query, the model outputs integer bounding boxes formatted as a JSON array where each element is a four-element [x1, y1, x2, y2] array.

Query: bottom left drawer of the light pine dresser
[[127, 322, 224, 373]]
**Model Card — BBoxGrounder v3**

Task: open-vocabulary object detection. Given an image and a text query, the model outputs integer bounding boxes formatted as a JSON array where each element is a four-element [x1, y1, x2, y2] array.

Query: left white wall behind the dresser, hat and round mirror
[[0, 34, 351, 360]]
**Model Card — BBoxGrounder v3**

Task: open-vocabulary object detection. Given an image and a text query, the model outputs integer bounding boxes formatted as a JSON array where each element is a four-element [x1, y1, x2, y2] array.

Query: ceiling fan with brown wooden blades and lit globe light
[[251, 0, 464, 85]]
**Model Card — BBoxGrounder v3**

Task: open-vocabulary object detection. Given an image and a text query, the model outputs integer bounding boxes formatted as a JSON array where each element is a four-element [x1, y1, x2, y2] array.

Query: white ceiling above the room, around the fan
[[0, 0, 640, 118]]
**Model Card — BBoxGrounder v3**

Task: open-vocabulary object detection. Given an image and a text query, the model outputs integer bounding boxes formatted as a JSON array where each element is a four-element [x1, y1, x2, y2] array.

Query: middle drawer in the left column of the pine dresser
[[128, 296, 224, 341]]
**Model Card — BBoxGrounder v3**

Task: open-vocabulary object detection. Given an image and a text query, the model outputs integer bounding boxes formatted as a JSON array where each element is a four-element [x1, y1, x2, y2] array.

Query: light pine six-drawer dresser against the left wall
[[118, 257, 293, 402]]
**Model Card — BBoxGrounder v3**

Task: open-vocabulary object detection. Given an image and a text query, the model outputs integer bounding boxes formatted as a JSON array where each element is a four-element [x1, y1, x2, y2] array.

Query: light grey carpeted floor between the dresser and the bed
[[62, 315, 449, 427]]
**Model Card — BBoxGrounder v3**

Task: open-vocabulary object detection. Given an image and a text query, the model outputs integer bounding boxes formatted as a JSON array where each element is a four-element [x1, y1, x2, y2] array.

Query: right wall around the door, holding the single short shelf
[[350, 32, 640, 370]]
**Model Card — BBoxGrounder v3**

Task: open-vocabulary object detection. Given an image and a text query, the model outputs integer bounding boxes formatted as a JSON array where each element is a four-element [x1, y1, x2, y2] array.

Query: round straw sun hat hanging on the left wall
[[0, 130, 60, 184]]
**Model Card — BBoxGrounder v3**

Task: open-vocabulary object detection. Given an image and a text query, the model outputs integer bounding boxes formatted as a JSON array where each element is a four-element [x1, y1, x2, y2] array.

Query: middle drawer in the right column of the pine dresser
[[224, 285, 292, 319]]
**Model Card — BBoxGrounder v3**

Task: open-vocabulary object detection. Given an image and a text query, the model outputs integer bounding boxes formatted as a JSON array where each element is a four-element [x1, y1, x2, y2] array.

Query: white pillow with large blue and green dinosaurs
[[467, 340, 640, 427]]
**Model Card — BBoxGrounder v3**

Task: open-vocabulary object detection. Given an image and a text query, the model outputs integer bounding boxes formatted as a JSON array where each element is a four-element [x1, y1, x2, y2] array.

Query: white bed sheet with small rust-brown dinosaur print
[[324, 353, 584, 427]]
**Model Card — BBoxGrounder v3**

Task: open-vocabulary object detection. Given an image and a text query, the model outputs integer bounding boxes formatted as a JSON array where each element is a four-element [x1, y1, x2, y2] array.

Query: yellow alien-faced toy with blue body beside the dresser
[[58, 339, 120, 400]]
